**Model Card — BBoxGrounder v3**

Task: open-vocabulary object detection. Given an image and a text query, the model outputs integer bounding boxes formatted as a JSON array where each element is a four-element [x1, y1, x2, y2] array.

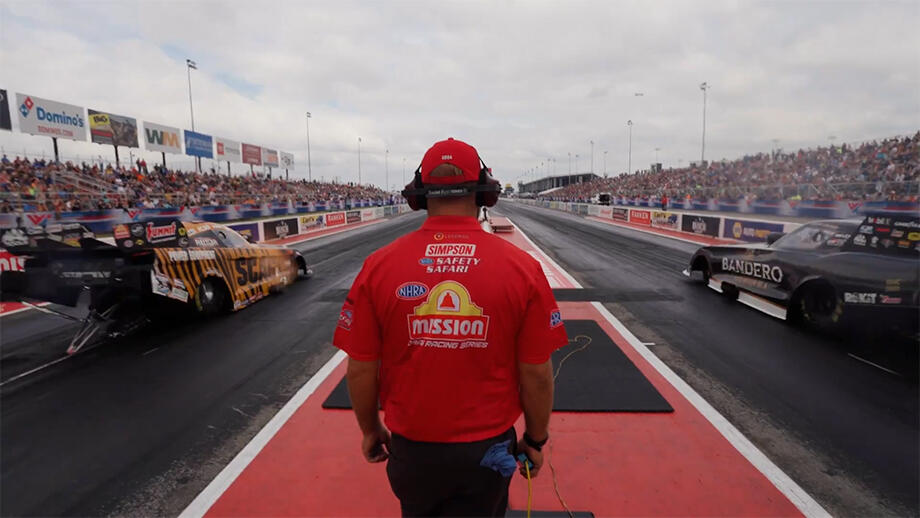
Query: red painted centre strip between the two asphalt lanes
[[198, 221, 801, 516]]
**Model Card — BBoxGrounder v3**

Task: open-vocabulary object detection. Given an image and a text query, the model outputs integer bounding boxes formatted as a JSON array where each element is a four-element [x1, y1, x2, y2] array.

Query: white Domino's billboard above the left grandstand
[[16, 93, 86, 140]]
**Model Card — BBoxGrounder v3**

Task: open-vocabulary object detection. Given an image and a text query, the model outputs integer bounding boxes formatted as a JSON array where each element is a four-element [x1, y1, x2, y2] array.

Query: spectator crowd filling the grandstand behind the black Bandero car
[[542, 131, 920, 202]]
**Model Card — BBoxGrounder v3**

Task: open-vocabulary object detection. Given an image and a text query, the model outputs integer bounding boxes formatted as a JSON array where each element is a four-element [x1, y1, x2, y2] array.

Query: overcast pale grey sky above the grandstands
[[0, 0, 920, 190]]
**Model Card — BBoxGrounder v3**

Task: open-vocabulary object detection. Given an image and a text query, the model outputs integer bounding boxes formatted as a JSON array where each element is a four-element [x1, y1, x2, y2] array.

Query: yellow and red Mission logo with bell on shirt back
[[406, 281, 489, 349]]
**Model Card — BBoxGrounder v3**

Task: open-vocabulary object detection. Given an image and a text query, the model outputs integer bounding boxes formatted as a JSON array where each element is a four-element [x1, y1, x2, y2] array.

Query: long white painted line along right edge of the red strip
[[506, 215, 830, 518]]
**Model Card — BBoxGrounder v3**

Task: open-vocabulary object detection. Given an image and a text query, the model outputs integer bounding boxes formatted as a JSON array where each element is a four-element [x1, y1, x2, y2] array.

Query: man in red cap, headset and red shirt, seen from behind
[[333, 139, 568, 516]]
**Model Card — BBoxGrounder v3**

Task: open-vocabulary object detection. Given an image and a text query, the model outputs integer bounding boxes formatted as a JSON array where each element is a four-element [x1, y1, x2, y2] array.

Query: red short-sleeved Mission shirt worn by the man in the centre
[[333, 216, 568, 442]]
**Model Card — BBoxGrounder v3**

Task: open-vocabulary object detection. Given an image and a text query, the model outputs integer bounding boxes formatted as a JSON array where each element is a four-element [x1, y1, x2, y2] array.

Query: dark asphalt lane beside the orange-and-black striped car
[[0, 214, 422, 516]]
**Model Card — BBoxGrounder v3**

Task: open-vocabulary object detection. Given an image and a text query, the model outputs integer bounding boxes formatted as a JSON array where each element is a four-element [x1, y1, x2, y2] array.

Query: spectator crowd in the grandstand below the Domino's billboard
[[0, 155, 389, 213]]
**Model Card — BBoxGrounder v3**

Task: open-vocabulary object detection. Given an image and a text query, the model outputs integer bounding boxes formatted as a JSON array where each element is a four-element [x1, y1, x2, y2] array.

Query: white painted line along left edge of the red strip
[[179, 351, 346, 518]]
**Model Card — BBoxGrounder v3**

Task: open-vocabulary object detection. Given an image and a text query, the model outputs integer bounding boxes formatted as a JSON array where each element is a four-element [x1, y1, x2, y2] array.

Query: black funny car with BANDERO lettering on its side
[[684, 213, 920, 335]]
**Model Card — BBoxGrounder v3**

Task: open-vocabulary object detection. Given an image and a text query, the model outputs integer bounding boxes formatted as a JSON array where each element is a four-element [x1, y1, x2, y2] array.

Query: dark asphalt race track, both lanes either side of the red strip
[[0, 202, 920, 516]]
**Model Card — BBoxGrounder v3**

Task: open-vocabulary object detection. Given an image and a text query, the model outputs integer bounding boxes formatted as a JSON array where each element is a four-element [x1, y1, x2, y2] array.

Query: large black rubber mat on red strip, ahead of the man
[[323, 320, 674, 412]]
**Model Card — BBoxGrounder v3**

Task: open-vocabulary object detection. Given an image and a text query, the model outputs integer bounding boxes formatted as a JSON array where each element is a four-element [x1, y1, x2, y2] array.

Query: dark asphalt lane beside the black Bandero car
[[494, 202, 920, 516]]
